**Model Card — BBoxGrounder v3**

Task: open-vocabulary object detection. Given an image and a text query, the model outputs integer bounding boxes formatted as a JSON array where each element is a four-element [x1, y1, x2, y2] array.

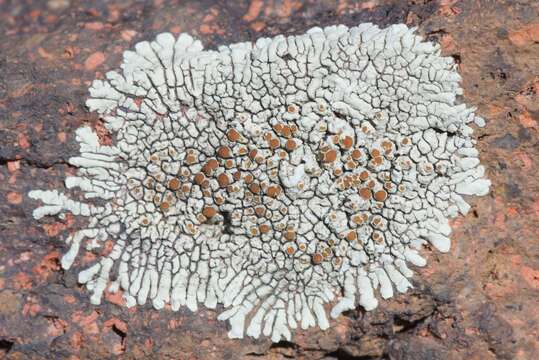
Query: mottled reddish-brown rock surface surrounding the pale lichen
[[0, 0, 539, 359]]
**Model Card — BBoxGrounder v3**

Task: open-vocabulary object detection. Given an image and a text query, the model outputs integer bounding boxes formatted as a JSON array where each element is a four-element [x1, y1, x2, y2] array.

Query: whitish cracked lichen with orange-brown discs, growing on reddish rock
[[29, 24, 490, 342]]
